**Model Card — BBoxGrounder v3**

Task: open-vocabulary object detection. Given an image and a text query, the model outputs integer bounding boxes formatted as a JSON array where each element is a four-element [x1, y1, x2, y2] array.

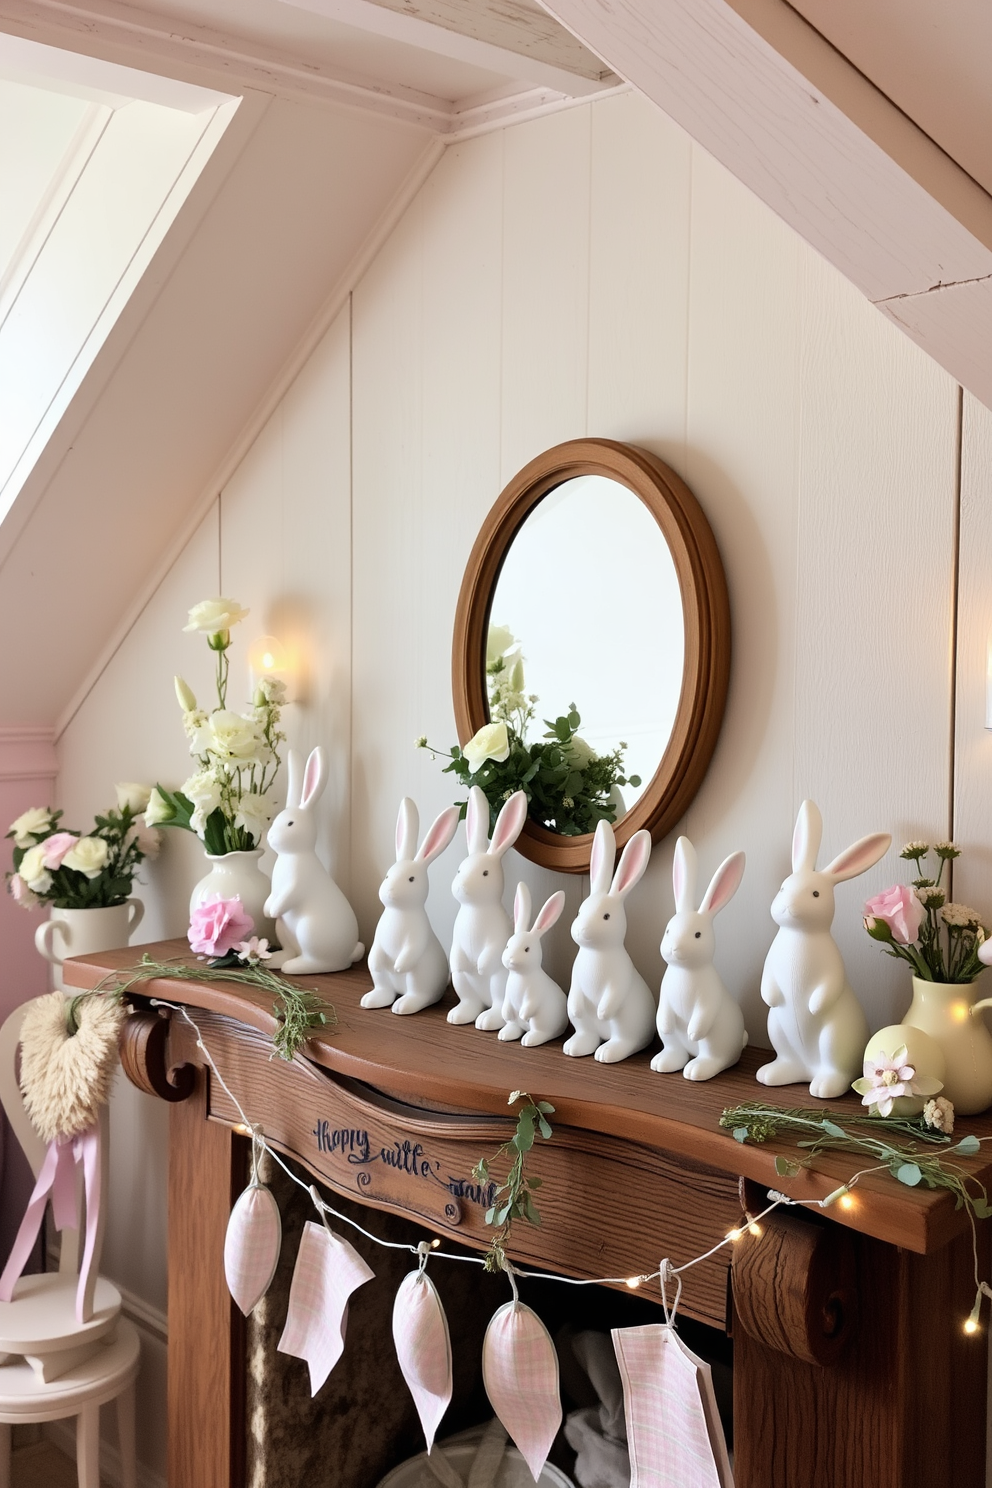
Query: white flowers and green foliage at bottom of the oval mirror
[[416, 625, 641, 836]]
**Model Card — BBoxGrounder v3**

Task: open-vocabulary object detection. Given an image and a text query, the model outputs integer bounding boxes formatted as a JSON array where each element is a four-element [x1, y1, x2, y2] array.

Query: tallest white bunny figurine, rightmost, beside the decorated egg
[[757, 801, 892, 1101]]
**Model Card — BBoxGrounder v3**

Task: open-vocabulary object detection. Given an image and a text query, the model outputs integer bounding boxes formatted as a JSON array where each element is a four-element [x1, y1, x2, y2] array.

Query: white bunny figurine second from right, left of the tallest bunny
[[651, 838, 748, 1080]]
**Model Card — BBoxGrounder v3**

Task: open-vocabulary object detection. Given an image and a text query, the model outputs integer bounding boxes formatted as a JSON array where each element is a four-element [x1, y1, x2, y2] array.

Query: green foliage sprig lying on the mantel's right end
[[720, 1101, 992, 1219]]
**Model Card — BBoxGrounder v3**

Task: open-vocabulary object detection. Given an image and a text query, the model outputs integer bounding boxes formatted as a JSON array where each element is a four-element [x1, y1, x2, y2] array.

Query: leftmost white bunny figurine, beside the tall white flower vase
[[265, 745, 364, 976]]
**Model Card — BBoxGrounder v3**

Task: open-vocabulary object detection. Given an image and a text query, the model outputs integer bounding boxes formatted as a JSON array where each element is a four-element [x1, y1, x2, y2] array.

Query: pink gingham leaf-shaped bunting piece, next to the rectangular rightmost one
[[482, 1302, 562, 1482]]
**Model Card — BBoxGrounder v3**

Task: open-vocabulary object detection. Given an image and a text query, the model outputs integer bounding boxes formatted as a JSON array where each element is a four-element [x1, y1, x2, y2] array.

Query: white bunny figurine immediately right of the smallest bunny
[[565, 821, 654, 1064]]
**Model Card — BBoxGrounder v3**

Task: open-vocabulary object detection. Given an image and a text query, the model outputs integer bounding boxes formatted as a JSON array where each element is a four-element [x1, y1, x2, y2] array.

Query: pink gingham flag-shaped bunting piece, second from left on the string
[[278, 1220, 375, 1396]]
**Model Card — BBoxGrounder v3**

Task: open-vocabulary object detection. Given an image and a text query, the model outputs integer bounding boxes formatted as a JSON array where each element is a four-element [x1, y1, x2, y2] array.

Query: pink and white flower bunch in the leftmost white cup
[[7, 781, 161, 909]]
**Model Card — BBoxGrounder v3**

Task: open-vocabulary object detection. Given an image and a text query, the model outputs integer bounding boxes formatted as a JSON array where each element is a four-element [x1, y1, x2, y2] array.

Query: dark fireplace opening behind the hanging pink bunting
[[244, 1155, 733, 1488]]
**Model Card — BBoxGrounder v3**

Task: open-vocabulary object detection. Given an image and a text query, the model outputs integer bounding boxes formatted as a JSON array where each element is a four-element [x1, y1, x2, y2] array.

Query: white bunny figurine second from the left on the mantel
[[361, 796, 458, 1013]]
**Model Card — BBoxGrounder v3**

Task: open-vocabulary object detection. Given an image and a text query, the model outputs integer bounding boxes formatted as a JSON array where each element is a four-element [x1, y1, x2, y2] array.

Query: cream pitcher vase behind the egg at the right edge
[[903, 976, 992, 1116]]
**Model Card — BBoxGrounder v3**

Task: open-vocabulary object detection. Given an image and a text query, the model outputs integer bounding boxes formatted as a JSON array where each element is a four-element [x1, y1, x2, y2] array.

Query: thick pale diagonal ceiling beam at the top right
[[540, 0, 992, 406]]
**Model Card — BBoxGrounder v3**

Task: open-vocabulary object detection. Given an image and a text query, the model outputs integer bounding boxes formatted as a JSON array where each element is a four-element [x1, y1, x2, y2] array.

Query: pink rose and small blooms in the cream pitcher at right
[[864, 842, 989, 982]]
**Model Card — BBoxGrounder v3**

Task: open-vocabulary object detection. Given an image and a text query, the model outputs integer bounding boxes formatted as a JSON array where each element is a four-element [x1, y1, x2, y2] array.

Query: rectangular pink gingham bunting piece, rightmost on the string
[[613, 1323, 733, 1488]]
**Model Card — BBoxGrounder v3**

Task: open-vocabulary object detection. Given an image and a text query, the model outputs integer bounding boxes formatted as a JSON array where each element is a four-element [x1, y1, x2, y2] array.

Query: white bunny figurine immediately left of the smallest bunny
[[448, 786, 526, 1033]]
